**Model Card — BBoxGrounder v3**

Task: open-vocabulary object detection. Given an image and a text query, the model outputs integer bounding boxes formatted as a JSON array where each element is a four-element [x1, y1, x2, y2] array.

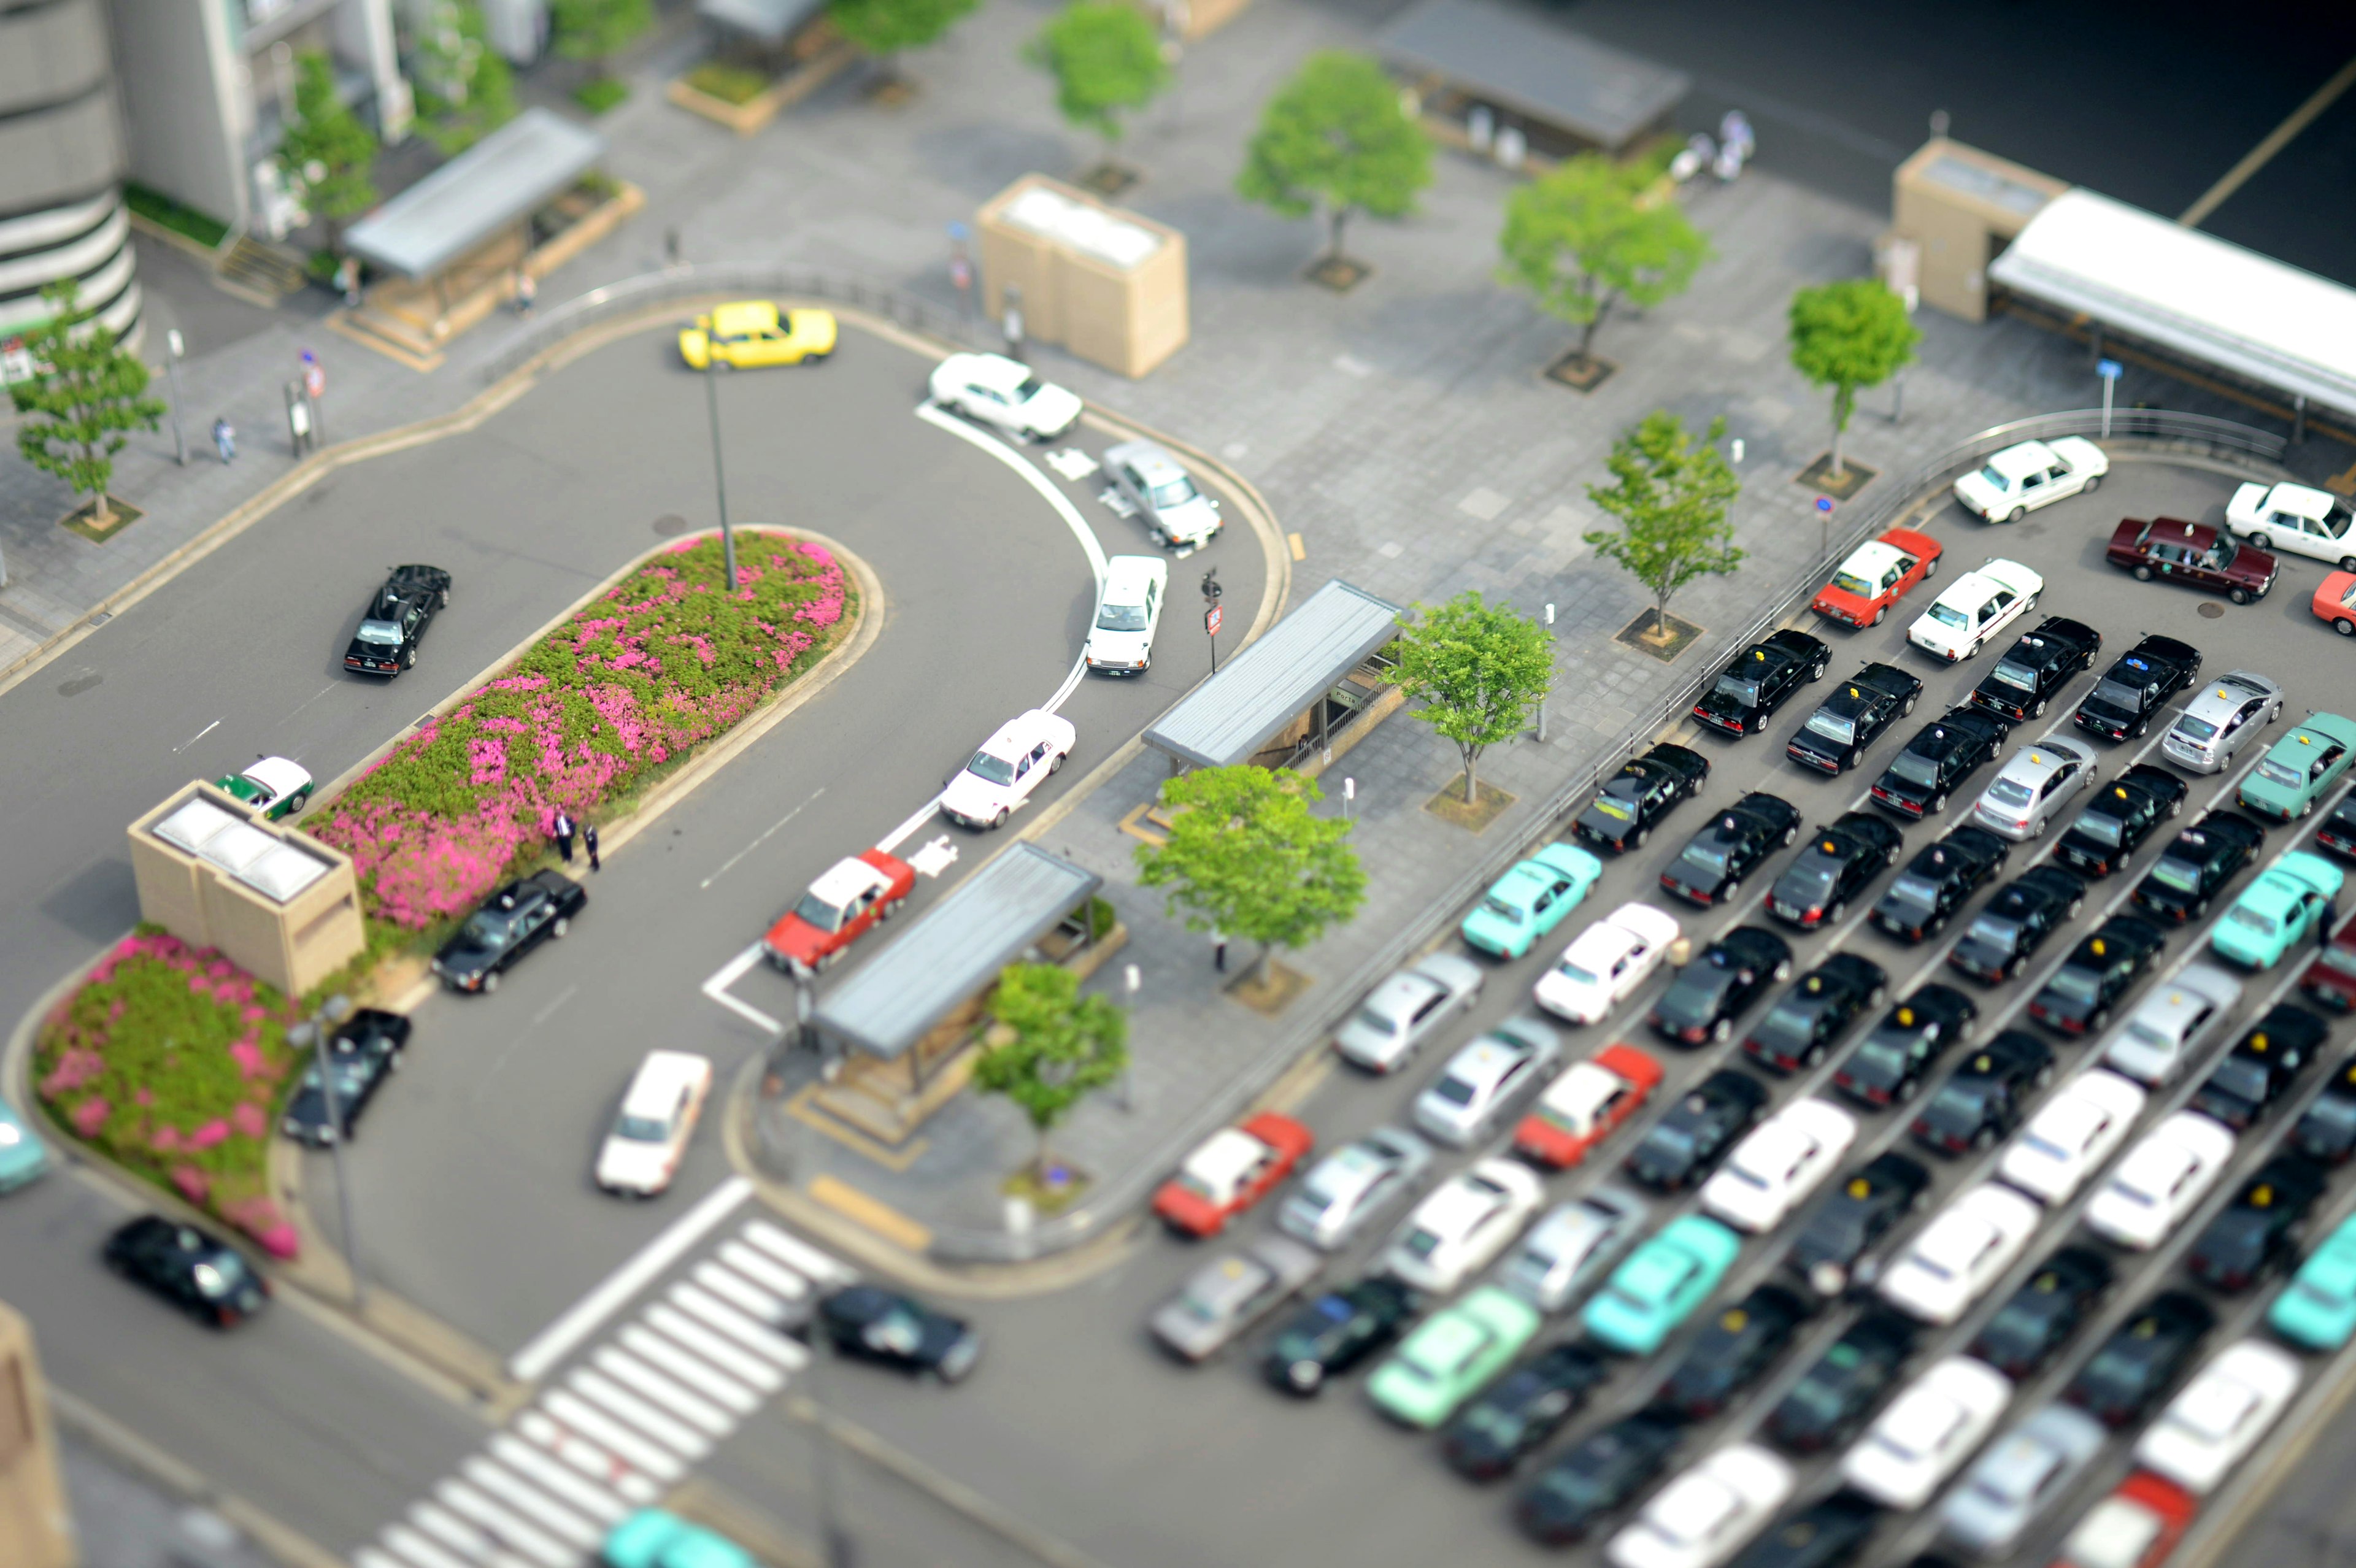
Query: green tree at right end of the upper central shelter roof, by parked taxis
[[1390, 591, 1555, 805]]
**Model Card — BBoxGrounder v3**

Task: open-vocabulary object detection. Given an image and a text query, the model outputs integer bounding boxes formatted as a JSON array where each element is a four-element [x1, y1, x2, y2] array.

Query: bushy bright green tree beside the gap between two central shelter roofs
[[1138, 765, 1366, 975]]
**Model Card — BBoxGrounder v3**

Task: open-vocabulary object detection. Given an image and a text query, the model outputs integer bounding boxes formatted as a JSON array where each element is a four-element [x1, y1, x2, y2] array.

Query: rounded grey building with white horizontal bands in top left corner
[[0, 0, 139, 382]]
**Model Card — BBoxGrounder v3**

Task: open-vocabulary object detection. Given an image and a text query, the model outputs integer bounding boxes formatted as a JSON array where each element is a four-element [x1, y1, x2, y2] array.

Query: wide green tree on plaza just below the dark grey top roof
[[1498, 153, 1711, 358]]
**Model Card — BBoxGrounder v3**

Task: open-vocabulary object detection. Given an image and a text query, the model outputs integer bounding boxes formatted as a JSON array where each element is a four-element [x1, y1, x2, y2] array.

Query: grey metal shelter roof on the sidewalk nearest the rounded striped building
[[344, 109, 606, 278]]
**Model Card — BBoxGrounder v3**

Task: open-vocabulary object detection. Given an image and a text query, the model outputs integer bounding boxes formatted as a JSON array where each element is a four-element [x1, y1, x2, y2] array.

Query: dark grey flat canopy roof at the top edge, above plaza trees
[[1374, 0, 1692, 153]]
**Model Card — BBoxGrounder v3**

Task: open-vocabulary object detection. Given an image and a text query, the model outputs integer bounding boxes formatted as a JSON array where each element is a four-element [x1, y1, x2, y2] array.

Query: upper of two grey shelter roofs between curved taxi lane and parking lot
[[1145, 577, 1399, 767]]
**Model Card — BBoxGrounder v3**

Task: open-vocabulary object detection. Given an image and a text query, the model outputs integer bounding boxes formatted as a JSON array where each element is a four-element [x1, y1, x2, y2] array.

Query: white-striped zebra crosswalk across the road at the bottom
[[353, 1220, 855, 1568]]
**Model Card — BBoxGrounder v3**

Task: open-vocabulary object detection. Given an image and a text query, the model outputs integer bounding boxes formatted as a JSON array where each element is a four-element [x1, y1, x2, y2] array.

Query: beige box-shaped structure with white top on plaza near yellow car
[[973, 174, 1187, 377]]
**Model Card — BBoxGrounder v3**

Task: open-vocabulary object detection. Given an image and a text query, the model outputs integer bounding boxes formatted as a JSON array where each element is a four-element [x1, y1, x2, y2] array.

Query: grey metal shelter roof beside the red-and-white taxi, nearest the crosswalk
[[815, 843, 1105, 1062]]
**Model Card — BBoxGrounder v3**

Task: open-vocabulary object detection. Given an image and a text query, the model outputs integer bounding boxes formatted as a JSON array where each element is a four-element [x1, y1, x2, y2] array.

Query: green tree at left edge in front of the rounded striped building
[[7, 278, 165, 528]]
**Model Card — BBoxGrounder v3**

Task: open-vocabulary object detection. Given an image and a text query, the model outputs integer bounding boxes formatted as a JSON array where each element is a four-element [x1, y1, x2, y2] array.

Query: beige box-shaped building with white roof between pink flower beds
[[129, 782, 368, 996]]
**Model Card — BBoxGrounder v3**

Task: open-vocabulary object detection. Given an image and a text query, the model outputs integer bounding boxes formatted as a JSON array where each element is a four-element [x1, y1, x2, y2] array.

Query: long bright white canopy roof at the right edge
[[1988, 191, 2356, 417]]
